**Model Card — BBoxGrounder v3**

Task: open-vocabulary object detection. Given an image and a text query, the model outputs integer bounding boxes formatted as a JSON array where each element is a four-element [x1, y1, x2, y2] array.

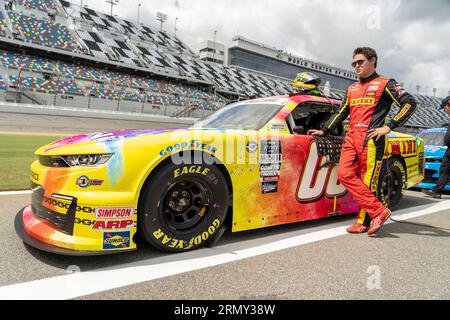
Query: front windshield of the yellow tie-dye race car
[[193, 101, 283, 130]]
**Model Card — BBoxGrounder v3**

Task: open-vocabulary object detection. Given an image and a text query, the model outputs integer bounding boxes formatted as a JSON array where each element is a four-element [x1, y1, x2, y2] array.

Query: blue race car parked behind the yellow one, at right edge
[[415, 128, 450, 191]]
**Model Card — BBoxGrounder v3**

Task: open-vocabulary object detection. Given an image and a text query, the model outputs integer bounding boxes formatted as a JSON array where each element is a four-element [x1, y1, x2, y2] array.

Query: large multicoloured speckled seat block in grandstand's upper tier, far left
[[8, 11, 77, 51]]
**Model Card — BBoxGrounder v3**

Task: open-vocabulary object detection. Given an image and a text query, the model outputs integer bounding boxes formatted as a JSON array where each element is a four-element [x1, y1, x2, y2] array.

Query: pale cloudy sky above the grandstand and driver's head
[[78, 0, 450, 97]]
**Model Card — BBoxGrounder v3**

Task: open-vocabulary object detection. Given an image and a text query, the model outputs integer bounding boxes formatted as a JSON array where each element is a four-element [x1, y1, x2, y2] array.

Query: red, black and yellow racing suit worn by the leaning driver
[[325, 72, 417, 226]]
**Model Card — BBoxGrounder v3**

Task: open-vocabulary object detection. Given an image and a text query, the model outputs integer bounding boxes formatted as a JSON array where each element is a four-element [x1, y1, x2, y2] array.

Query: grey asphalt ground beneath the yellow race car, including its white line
[[0, 114, 450, 300]]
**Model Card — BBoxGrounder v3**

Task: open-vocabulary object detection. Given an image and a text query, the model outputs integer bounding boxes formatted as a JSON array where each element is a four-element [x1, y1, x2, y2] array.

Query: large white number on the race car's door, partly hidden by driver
[[297, 142, 347, 202]]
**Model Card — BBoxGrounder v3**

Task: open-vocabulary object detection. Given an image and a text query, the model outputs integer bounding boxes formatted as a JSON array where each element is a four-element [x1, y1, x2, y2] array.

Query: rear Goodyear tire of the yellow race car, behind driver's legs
[[378, 158, 406, 210]]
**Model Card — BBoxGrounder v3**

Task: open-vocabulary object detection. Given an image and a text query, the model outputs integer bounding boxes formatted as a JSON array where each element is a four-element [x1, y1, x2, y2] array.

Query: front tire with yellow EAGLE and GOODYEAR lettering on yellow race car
[[139, 164, 229, 252]]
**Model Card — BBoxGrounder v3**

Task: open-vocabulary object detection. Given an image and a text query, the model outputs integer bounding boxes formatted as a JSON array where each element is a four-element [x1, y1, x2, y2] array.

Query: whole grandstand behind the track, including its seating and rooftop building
[[0, 0, 448, 128]]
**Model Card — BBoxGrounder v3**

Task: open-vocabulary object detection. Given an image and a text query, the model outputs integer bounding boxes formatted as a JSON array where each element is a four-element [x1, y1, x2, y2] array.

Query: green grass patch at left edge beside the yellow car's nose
[[0, 134, 61, 191]]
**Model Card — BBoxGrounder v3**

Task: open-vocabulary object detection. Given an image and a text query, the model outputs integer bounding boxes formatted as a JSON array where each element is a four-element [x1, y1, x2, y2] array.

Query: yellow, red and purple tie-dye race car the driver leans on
[[15, 94, 424, 255]]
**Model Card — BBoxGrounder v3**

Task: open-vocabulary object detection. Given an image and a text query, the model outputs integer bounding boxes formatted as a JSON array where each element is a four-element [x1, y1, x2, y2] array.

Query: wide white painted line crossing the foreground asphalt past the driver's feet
[[0, 200, 450, 300]]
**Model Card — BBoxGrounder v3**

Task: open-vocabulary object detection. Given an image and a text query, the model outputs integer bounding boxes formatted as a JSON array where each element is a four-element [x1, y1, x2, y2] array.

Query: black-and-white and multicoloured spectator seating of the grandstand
[[0, 0, 448, 127]]
